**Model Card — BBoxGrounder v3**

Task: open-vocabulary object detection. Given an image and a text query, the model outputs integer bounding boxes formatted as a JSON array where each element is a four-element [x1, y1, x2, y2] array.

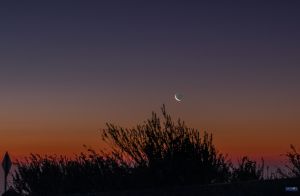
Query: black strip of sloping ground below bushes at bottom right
[[54, 178, 300, 196]]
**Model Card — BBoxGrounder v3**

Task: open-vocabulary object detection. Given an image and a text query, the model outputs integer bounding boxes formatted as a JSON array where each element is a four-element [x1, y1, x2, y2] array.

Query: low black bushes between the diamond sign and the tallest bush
[[13, 150, 127, 195]]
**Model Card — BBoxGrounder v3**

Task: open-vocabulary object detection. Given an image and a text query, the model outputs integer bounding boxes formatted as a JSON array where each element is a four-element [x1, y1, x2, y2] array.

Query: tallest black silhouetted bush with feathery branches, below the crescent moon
[[102, 106, 230, 186]]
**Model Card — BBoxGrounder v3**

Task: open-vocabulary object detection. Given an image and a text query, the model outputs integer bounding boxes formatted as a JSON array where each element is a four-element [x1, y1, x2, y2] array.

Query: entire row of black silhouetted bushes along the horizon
[[7, 106, 300, 195]]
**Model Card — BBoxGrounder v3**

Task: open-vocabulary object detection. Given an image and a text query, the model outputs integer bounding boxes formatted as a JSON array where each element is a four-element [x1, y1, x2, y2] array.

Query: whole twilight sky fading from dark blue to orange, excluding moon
[[0, 1, 300, 167]]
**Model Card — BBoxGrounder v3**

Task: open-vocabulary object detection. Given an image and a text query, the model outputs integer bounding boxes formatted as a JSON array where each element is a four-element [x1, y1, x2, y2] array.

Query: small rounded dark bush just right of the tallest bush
[[232, 156, 264, 182]]
